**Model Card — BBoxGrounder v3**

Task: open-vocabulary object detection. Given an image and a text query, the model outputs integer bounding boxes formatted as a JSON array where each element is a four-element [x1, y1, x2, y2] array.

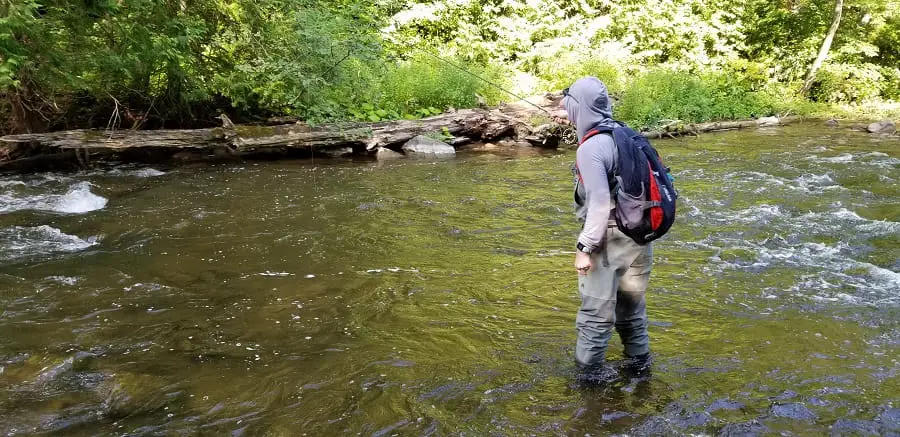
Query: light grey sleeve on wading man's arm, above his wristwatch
[[576, 135, 615, 251]]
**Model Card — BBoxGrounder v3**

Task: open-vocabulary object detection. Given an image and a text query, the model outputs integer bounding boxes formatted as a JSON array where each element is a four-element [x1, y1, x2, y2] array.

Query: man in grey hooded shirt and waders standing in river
[[560, 77, 653, 372]]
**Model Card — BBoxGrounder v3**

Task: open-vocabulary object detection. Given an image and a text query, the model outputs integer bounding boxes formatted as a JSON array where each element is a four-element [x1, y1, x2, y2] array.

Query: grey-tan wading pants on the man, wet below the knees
[[575, 225, 653, 367]]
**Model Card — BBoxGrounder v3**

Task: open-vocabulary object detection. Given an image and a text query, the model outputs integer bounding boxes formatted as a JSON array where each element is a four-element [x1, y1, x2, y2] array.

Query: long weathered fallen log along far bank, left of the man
[[0, 95, 558, 170]]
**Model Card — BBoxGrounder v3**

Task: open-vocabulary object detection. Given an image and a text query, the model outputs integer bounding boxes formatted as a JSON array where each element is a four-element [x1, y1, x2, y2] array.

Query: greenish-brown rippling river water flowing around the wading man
[[0, 126, 900, 436]]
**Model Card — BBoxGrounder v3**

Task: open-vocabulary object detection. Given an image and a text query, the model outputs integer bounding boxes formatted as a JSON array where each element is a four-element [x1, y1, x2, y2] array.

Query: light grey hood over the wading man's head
[[562, 76, 616, 141]]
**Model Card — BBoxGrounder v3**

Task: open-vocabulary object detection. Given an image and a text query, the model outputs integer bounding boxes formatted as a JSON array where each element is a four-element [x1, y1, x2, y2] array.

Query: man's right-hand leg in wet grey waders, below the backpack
[[616, 245, 653, 358]]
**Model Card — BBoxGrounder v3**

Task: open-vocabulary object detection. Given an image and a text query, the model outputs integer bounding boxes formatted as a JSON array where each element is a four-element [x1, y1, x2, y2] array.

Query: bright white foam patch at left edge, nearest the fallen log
[[0, 182, 107, 214]]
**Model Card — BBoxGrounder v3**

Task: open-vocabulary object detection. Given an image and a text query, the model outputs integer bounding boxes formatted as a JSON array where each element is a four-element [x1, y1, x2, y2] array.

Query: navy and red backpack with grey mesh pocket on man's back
[[575, 122, 678, 245]]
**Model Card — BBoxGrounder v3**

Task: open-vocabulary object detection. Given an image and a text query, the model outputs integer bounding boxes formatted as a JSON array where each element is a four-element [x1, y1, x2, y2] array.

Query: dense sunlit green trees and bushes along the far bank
[[0, 0, 900, 132]]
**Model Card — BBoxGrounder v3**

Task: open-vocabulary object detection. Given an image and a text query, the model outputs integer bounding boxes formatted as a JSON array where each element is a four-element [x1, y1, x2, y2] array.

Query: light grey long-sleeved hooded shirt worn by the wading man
[[563, 77, 619, 251]]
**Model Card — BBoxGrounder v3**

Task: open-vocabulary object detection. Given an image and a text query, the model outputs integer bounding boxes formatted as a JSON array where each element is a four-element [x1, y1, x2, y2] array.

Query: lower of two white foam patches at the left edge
[[0, 225, 98, 261]]
